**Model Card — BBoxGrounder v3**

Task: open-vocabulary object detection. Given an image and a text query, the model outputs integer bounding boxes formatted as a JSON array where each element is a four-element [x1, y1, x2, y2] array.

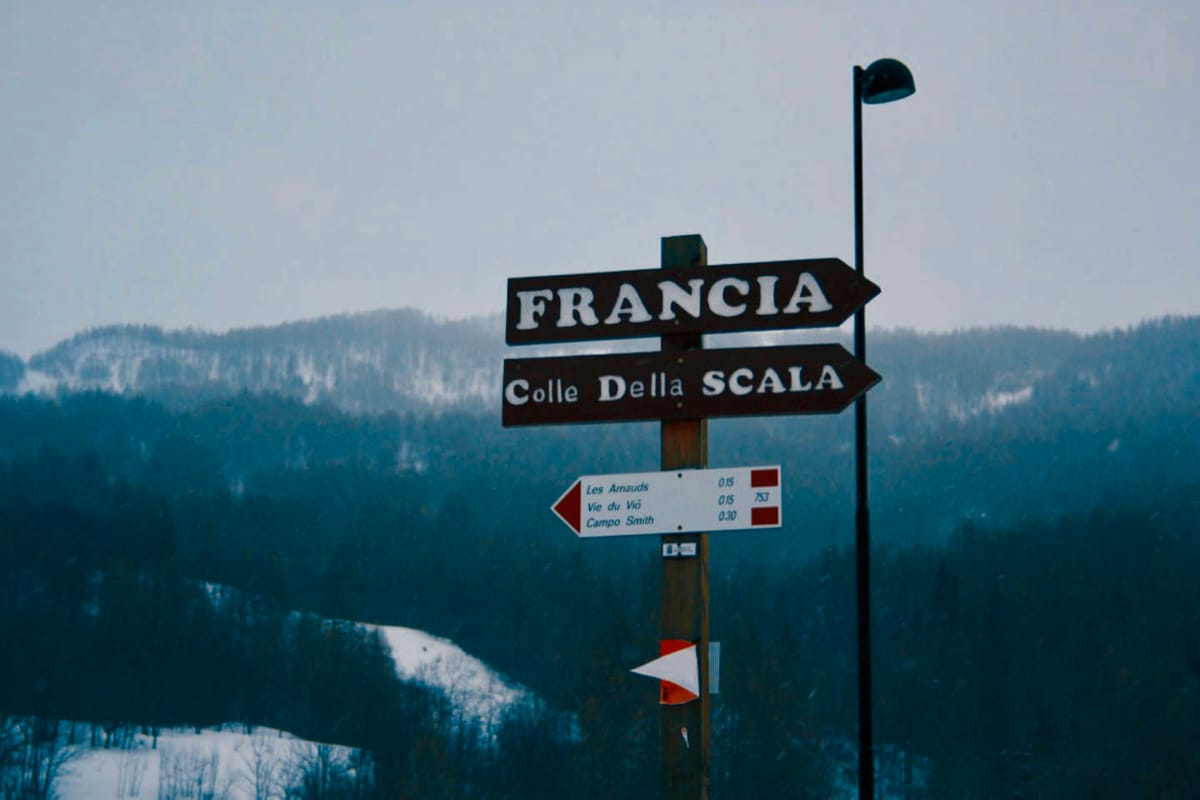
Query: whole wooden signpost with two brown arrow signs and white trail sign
[[502, 235, 880, 800]]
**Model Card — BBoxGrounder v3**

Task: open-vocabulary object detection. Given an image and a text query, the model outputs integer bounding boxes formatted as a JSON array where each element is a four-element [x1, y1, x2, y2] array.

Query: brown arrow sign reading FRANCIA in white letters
[[505, 258, 880, 344]]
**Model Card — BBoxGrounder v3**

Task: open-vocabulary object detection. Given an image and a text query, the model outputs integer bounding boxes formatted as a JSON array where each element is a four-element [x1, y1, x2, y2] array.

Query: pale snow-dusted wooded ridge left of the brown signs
[[0, 309, 503, 411]]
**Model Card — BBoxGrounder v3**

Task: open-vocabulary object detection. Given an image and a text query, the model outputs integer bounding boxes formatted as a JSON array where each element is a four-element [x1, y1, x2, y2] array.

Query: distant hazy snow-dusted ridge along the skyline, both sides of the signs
[[0, 309, 1200, 427]]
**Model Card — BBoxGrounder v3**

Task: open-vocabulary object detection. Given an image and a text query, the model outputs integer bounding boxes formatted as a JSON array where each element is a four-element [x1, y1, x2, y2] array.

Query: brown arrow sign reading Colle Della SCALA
[[502, 344, 880, 426]]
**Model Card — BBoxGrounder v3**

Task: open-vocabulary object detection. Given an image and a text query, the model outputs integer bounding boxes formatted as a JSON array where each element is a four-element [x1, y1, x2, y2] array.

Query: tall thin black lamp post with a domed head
[[853, 59, 917, 800]]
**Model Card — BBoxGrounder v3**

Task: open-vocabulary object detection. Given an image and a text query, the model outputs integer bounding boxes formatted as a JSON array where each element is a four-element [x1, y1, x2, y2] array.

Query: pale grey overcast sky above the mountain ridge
[[0, 0, 1200, 356]]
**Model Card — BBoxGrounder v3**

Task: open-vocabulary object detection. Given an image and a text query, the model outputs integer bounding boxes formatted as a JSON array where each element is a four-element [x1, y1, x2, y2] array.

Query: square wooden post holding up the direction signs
[[659, 234, 712, 800]]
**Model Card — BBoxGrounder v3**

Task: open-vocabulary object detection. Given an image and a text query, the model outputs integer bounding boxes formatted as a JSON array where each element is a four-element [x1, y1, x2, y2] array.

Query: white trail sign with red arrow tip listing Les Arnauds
[[552, 467, 782, 536]]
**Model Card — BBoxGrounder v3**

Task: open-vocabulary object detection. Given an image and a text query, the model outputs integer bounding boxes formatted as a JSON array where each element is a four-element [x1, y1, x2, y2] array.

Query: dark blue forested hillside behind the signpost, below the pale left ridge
[[0, 320, 1200, 798]]
